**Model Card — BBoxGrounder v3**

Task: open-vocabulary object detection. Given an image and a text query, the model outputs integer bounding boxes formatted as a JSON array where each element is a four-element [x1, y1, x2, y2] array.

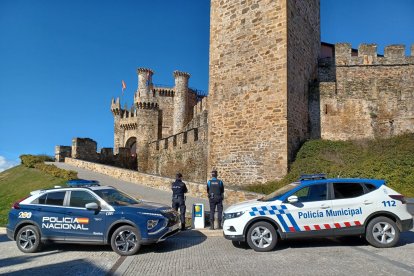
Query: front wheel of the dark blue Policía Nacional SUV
[[111, 225, 141, 256]]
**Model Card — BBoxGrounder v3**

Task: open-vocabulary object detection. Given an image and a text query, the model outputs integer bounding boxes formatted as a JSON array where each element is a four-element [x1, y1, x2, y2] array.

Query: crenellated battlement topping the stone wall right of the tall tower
[[335, 43, 414, 66]]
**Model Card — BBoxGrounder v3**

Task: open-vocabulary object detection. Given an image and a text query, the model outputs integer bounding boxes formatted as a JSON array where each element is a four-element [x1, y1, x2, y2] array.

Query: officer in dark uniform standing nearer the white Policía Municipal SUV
[[207, 170, 224, 229]]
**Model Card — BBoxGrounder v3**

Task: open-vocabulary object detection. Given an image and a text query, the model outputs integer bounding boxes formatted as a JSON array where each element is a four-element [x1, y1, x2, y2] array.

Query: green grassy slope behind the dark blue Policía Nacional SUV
[[0, 165, 65, 226]]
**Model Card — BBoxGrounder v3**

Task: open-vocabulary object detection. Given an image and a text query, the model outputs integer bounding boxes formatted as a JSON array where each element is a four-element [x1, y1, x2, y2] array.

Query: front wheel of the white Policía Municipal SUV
[[246, 221, 277, 252]]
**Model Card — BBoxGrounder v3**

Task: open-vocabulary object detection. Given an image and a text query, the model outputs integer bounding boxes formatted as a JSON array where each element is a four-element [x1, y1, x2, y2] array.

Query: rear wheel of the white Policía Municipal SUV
[[365, 217, 400, 248]]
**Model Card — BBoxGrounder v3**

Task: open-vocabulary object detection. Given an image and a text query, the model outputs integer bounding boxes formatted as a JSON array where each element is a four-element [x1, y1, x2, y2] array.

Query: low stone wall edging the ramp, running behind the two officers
[[65, 158, 263, 204]]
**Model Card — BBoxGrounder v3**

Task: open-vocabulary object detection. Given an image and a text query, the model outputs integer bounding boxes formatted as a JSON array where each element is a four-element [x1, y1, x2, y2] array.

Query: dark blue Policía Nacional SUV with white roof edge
[[7, 184, 180, 256]]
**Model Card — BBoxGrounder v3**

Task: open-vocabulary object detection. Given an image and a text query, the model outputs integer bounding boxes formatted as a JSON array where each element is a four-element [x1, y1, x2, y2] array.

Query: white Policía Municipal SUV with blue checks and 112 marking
[[223, 175, 413, 252]]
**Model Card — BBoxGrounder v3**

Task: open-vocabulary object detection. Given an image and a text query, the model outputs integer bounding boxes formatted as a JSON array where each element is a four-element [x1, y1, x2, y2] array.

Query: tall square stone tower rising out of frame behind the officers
[[208, 0, 320, 185]]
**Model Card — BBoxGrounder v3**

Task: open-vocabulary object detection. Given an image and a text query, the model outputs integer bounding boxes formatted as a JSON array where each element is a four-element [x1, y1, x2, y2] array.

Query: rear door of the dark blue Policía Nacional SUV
[[31, 191, 66, 241]]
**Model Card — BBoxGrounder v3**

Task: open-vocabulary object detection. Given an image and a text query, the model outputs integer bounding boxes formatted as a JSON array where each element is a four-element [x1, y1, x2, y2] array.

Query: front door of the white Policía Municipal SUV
[[285, 183, 333, 236]]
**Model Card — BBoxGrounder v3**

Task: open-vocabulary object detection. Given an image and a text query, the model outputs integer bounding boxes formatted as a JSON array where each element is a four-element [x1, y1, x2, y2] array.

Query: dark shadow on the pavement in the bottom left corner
[[0, 259, 106, 276]]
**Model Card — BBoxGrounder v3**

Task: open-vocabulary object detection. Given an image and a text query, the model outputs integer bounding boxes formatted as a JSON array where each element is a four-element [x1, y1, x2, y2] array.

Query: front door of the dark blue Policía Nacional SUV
[[65, 190, 105, 243]]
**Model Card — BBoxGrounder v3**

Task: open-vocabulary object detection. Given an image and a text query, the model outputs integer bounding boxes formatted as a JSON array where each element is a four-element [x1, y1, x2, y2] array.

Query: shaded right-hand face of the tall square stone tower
[[287, 0, 321, 163]]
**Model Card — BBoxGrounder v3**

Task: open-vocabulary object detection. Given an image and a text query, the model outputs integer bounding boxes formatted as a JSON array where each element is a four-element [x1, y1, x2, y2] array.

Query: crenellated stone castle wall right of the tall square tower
[[310, 43, 414, 140]]
